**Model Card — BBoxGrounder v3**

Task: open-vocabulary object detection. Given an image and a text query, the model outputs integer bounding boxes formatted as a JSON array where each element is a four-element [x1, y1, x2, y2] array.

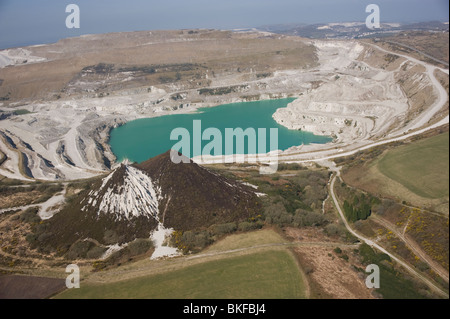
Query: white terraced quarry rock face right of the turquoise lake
[[273, 41, 436, 143]]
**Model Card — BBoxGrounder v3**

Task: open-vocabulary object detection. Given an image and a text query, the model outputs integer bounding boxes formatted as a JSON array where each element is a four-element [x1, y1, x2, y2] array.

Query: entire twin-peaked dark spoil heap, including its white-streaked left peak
[[35, 152, 258, 253]]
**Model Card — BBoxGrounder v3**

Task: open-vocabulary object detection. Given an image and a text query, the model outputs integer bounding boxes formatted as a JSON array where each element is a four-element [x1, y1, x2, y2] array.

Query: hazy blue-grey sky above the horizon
[[0, 0, 449, 48]]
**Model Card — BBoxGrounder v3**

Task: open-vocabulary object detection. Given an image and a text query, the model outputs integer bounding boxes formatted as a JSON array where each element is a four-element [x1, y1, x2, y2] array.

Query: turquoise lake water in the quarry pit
[[109, 98, 332, 163]]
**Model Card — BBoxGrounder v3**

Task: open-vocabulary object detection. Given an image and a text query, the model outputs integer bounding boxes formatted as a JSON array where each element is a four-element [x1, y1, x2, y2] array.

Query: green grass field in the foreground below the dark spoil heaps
[[56, 251, 305, 299]]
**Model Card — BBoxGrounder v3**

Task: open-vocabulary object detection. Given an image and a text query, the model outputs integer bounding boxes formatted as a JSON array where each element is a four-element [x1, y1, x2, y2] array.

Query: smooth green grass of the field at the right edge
[[378, 132, 449, 198]]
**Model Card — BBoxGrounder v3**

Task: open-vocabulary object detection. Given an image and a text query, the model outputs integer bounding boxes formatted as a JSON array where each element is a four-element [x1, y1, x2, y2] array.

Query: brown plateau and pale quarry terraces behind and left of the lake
[[0, 30, 317, 180]]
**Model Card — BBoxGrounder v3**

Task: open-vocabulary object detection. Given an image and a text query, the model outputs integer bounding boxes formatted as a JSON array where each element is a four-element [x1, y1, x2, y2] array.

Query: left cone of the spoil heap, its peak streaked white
[[34, 165, 158, 252]]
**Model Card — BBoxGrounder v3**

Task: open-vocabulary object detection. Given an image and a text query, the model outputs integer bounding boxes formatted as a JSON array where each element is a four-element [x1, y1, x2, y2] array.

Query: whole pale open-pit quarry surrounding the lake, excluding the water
[[0, 30, 449, 180]]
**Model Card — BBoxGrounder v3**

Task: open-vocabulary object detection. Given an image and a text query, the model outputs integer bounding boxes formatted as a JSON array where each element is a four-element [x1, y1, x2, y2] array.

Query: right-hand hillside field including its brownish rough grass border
[[343, 128, 449, 214]]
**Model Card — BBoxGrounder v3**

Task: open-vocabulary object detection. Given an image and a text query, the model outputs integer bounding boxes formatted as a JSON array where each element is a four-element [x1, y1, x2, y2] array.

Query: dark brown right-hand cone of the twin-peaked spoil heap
[[136, 152, 258, 230]]
